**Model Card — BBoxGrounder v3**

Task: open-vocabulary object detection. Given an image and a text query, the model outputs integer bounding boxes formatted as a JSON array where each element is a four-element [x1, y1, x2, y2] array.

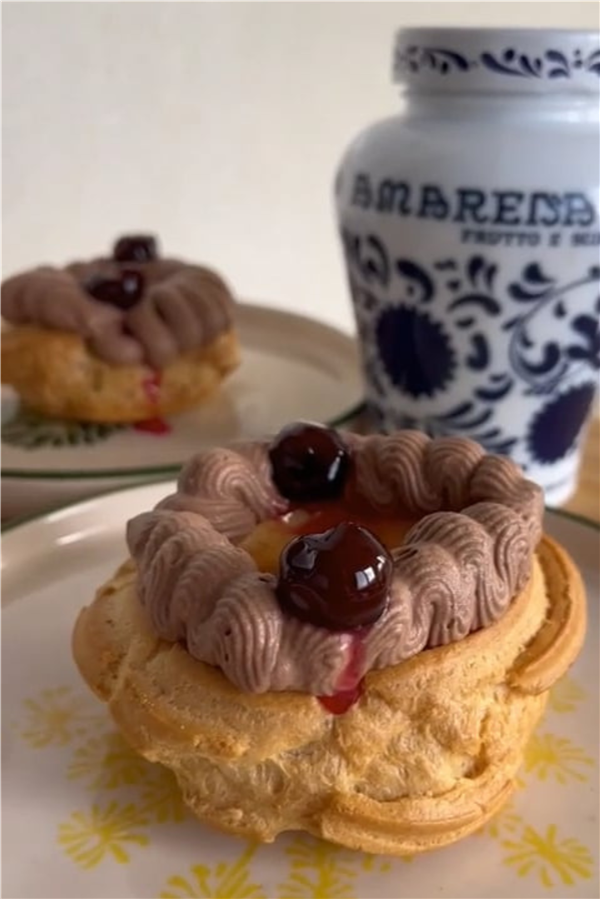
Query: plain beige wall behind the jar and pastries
[[2, 0, 599, 330]]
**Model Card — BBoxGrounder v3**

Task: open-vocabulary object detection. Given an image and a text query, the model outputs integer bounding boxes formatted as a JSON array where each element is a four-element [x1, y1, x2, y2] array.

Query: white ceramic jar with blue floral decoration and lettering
[[336, 28, 600, 503]]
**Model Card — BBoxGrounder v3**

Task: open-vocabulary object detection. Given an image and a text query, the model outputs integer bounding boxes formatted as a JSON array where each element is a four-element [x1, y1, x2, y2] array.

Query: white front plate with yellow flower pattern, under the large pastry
[[0, 483, 600, 899]]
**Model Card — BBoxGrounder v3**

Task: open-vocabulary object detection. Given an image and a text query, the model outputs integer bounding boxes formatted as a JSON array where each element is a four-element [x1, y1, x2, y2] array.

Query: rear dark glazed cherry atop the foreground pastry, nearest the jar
[[269, 422, 350, 502]]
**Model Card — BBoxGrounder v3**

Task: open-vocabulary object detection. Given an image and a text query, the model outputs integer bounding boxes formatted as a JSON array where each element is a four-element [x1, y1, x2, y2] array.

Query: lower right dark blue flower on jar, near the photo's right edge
[[526, 381, 596, 465]]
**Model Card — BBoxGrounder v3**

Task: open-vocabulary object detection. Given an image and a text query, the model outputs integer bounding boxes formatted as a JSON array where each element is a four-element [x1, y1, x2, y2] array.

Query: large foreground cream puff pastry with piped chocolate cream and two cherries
[[73, 423, 586, 854]]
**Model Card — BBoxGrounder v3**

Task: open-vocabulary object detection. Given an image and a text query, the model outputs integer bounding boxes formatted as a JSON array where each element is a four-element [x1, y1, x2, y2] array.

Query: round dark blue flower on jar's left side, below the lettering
[[375, 305, 456, 397]]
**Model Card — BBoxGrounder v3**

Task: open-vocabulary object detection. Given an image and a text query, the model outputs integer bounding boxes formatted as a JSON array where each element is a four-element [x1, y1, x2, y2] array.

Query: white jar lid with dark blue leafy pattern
[[394, 28, 600, 95]]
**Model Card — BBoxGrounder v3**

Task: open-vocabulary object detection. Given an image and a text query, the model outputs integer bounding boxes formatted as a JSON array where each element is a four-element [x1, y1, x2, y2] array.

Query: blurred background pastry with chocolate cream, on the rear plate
[[0, 235, 239, 423]]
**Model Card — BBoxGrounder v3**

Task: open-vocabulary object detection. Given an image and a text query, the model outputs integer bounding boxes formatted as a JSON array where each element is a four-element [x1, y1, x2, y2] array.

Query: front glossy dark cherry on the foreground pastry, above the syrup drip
[[277, 522, 393, 631]]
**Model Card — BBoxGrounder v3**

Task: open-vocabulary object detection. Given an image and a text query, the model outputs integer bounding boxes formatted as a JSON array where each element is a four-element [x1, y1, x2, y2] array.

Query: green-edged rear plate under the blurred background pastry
[[0, 303, 362, 517]]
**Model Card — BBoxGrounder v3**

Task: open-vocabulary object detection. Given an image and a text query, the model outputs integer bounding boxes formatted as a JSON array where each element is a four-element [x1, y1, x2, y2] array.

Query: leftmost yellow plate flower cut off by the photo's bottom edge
[[159, 844, 265, 899]]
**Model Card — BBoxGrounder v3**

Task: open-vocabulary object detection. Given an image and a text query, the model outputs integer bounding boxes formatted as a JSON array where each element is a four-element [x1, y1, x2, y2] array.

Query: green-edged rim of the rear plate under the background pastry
[[0, 300, 366, 482]]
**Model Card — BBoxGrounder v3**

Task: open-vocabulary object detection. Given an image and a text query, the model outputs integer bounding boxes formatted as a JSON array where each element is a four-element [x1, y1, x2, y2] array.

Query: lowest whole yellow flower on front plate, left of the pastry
[[58, 801, 149, 869]]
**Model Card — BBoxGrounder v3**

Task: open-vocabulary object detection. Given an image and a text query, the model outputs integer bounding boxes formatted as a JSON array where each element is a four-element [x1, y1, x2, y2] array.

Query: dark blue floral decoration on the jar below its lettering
[[342, 229, 600, 468]]
